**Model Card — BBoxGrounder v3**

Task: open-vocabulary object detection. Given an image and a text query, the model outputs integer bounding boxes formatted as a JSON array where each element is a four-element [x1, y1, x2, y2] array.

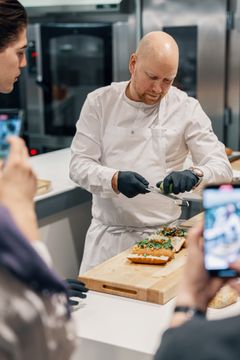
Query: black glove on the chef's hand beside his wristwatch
[[156, 170, 198, 194]]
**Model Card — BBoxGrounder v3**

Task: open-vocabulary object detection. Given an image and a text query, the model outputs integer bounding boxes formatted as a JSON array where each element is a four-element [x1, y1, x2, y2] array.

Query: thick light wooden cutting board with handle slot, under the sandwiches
[[79, 248, 187, 304]]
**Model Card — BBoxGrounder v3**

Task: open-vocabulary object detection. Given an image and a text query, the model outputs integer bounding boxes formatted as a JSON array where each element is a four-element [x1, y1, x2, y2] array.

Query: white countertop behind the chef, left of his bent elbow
[[30, 148, 77, 200]]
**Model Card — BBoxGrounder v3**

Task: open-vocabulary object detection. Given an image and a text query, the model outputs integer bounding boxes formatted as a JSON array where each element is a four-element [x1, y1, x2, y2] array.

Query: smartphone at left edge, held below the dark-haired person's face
[[0, 109, 23, 159]]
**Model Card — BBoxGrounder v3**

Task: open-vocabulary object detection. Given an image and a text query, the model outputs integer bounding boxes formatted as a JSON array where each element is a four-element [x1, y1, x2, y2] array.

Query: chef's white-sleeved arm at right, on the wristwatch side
[[185, 99, 233, 188]]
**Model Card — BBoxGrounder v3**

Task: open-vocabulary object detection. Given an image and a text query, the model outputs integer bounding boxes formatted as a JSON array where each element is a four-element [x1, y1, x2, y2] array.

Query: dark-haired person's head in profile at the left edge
[[0, 0, 27, 94]]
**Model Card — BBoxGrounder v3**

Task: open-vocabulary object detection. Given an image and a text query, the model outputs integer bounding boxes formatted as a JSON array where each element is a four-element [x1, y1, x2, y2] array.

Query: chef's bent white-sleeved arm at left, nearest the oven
[[70, 96, 118, 197]]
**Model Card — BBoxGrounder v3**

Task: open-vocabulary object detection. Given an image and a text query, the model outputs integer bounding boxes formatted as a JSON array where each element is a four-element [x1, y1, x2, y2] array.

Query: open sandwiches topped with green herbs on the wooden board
[[127, 227, 186, 265]]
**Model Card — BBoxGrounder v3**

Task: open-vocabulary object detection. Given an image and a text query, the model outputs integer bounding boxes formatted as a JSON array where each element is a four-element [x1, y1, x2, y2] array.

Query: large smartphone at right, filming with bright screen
[[203, 184, 240, 277]]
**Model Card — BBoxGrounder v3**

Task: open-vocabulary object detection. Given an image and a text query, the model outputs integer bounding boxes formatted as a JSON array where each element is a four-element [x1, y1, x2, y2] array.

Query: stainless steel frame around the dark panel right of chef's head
[[143, 0, 227, 140]]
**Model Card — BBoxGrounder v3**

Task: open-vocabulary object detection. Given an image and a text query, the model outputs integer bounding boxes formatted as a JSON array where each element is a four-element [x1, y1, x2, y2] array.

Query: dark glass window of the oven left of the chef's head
[[49, 35, 105, 131]]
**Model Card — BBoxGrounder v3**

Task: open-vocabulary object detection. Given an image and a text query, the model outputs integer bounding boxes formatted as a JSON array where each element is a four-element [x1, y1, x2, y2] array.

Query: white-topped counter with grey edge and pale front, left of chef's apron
[[30, 148, 91, 278]]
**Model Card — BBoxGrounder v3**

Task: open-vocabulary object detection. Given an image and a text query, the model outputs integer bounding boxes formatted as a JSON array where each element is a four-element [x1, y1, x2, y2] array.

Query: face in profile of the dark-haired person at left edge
[[0, 28, 27, 94]]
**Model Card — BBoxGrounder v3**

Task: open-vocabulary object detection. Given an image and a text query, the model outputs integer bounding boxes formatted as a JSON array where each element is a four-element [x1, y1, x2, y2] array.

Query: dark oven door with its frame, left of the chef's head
[[28, 23, 112, 138]]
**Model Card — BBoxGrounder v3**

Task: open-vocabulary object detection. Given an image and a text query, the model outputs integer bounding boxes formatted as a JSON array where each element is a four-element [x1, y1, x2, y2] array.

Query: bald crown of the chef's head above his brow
[[136, 31, 179, 67]]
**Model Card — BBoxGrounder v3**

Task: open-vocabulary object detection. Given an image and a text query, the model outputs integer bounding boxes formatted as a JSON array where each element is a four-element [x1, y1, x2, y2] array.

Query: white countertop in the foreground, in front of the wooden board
[[73, 291, 240, 360]]
